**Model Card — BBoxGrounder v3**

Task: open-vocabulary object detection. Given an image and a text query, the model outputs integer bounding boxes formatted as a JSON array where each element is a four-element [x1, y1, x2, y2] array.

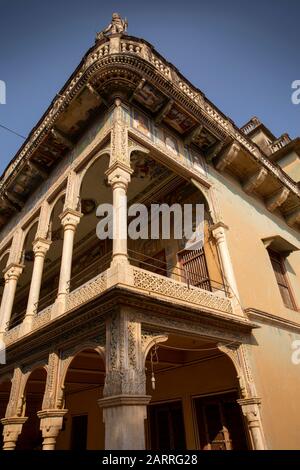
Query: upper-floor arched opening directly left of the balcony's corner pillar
[[70, 154, 112, 291]]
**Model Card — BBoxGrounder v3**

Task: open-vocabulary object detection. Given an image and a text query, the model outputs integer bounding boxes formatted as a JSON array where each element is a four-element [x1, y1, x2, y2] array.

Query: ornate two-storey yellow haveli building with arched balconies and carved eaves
[[0, 14, 300, 450]]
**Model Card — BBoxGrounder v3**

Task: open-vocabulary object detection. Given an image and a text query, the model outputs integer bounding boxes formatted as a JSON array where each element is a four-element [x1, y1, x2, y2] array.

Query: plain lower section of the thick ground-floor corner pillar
[[98, 395, 151, 450]]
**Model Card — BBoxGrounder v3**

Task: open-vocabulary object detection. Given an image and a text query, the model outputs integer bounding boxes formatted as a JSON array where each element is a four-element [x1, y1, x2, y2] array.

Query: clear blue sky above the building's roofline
[[0, 0, 300, 174]]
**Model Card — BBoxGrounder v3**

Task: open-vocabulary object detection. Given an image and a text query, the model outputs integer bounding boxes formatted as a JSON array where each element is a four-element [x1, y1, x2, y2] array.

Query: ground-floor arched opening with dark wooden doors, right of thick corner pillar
[[146, 335, 250, 450]]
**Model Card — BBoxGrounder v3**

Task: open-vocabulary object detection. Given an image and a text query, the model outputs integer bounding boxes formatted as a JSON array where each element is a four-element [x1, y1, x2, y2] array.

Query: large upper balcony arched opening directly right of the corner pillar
[[128, 151, 227, 295]]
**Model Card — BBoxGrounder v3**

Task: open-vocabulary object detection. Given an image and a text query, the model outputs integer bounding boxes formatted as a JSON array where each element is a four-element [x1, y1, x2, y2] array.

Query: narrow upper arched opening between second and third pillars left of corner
[[37, 194, 65, 312]]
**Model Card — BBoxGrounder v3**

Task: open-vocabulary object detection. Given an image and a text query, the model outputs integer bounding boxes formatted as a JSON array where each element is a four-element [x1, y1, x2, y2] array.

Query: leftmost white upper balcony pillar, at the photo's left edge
[[0, 263, 24, 339]]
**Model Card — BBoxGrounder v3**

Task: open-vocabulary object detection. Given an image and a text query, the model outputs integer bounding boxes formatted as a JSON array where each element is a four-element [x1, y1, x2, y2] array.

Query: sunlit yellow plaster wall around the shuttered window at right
[[211, 170, 300, 449]]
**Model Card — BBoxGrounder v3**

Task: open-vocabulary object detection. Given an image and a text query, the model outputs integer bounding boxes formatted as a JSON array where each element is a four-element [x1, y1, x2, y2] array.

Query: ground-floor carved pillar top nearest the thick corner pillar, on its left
[[37, 409, 68, 450]]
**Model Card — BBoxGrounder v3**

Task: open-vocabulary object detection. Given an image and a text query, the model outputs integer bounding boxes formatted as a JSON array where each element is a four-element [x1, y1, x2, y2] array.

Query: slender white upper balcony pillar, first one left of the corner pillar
[[57, 209, 82, 313]]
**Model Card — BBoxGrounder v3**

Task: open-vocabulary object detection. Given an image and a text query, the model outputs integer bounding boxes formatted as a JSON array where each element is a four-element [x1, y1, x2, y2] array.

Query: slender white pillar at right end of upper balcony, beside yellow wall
[[211, 222, 239, 299]]
